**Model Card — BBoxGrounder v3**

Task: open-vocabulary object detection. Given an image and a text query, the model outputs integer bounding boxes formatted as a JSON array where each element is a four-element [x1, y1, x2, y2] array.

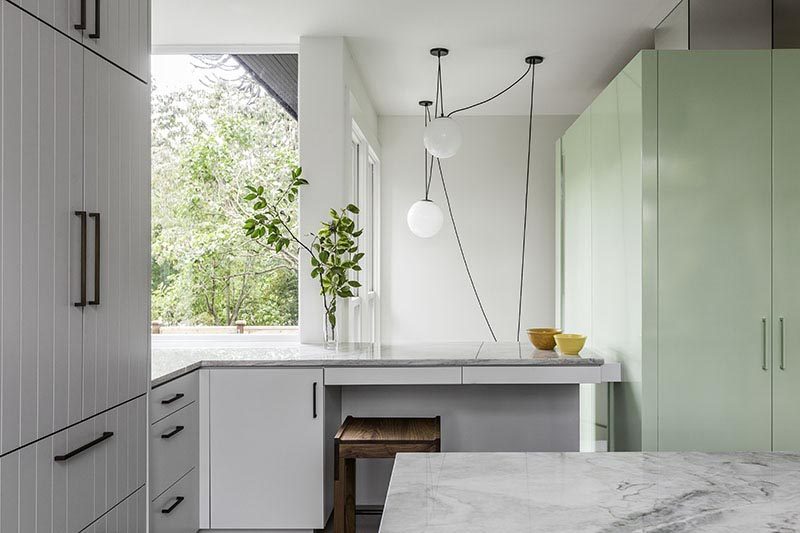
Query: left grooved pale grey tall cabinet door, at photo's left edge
[[0, 2, 83, 453]]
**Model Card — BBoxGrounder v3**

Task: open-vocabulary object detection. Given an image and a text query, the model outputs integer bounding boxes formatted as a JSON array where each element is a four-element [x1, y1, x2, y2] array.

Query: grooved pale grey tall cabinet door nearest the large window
[[83, 52, 150, 417]]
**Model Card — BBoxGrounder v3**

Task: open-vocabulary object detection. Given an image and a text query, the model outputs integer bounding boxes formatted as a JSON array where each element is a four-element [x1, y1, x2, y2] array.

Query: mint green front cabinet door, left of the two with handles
[[658, 50, 772, 451]]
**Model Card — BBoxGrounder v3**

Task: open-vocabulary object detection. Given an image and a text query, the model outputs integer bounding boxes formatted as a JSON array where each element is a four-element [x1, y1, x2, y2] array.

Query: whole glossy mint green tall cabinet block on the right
[[559, 50, 800, 451]]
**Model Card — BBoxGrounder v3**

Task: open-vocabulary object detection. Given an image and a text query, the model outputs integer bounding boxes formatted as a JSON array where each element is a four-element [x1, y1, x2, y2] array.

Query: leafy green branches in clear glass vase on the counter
[[244, 167, 364, 348]]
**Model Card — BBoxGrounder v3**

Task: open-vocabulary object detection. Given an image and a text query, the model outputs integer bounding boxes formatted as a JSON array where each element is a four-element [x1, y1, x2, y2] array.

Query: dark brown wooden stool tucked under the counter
[[333, 416, 442, 533]]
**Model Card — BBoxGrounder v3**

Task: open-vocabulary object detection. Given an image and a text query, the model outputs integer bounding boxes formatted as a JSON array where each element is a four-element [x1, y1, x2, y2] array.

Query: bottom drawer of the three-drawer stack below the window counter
[[150, 468, 200, 533]]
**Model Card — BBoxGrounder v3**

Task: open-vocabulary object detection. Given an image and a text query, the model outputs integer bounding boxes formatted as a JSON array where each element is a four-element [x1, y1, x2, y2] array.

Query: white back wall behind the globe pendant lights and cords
[[379, 115, 575, 342]]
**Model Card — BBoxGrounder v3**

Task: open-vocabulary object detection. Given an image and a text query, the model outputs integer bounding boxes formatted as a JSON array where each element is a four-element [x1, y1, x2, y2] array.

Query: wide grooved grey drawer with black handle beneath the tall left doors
[[0, 397, 147, 533]]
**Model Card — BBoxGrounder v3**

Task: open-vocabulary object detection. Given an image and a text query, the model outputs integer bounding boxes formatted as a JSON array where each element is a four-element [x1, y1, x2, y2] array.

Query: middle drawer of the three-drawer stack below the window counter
[[150, 402, 200, 499]]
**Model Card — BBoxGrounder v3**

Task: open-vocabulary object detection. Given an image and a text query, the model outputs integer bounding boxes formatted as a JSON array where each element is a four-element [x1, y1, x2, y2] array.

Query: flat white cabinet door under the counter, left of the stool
[[209, 368, 332, 529]]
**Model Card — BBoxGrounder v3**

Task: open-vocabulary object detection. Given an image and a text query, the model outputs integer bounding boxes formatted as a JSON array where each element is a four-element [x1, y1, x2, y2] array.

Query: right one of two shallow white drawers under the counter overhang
[[464, 366, 601, 385]]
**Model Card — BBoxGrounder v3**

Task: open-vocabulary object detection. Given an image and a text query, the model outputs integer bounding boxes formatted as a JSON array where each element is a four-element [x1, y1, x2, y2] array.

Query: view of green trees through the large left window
[[152, 56, 298, 325]]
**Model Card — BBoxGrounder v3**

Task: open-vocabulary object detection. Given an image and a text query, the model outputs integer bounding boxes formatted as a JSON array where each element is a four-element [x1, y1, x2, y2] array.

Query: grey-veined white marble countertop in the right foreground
[[380, 452, 800, 533]]
